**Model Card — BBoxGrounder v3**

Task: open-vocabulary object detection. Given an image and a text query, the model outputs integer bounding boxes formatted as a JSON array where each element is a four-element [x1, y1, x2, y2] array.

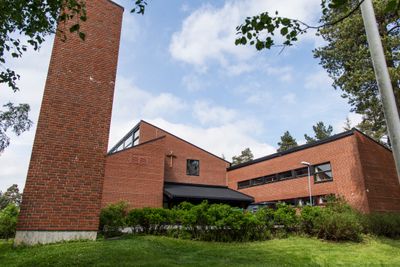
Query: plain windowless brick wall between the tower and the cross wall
[[102, 137, 165, 208]]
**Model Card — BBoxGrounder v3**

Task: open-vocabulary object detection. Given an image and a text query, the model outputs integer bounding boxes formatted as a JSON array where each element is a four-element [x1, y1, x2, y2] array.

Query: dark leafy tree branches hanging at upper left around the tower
[[0, 0, 146, 152]]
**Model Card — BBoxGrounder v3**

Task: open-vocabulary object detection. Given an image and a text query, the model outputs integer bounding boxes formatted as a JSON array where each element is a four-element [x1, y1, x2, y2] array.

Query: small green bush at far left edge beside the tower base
[[0, 204, 19, 239]]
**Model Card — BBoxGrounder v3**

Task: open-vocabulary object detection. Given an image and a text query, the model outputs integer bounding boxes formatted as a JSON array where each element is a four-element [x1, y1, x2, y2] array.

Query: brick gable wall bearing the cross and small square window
[[140, 121, 229, 185]]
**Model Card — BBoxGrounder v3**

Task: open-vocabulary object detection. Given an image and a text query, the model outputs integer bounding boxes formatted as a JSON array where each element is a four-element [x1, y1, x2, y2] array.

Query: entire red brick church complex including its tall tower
[[15, 0, 400, 244]]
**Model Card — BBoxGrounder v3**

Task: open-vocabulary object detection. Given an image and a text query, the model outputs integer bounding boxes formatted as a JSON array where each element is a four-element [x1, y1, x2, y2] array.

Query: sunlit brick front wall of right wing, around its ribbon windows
[[228, 135, 368, 214]]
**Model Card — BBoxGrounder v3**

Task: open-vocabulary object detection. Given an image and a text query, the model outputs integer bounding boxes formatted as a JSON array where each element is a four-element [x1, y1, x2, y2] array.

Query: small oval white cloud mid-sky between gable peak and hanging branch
[[193, 101, 237, 125]]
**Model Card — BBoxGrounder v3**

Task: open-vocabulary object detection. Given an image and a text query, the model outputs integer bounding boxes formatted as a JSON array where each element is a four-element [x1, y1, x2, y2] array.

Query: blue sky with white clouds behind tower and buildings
[[0, 0, 359, 191]]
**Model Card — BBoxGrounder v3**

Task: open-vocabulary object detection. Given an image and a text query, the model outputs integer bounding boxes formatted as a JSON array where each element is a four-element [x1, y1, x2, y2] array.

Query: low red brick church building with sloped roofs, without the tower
[[102, 121, 400, 215]]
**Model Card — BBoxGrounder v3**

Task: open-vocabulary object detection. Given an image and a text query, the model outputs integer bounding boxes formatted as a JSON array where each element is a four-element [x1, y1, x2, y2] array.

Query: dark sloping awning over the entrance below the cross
[[164, 182, 254, 203]]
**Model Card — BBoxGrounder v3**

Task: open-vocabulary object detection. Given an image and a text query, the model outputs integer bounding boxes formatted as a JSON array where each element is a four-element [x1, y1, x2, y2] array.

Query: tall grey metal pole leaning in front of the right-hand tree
[[361, 0, 400, 183]]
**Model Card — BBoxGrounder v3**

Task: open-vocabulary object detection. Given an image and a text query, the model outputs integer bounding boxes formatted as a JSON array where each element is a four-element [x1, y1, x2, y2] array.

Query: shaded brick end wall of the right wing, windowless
[[356, 133, 400, 211]]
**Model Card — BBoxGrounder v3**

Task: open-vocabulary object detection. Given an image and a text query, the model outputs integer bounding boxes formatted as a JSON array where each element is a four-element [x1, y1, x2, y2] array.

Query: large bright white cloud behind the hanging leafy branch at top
[[170, 0, 320, 70]]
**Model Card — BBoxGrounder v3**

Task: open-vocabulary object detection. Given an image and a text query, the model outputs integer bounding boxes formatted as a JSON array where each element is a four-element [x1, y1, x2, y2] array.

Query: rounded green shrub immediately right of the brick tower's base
[[99, 202, 128, 237]]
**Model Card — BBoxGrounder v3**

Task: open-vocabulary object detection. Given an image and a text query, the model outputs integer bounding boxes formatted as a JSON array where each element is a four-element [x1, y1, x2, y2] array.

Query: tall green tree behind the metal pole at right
[[314, 1, 400, 144]]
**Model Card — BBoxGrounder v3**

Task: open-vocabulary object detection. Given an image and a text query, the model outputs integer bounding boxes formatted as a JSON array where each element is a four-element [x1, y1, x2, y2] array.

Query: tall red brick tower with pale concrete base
[[15, 0, 123, 247]]
